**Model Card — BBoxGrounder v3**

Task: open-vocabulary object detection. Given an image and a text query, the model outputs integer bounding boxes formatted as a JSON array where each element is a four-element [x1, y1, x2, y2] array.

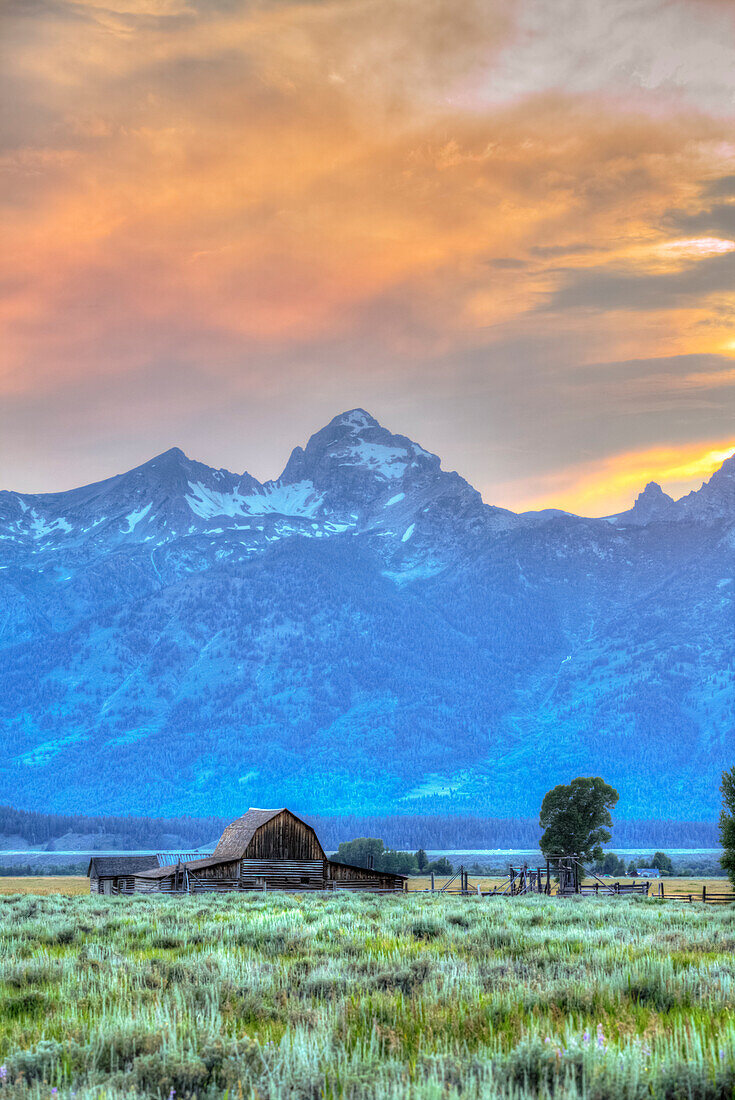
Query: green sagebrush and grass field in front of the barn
[[0, 893, 735, 1100]]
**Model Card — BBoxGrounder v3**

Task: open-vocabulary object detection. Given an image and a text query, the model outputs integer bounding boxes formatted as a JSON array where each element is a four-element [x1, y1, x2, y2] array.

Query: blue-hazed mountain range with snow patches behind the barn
[[0, 409, 735, 821]]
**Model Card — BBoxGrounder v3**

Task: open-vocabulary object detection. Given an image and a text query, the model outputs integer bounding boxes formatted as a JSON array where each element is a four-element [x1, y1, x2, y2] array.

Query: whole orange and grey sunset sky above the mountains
[[0, 0, 735, 515]]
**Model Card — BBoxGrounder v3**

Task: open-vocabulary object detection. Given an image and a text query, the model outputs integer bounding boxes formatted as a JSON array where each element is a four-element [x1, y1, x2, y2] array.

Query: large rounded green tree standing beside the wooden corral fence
[[539, 776, 618, 860]]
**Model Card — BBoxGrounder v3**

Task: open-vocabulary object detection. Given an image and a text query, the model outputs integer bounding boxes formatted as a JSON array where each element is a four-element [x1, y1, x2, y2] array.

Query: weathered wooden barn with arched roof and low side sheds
[[90, 807, 406, 893]]
